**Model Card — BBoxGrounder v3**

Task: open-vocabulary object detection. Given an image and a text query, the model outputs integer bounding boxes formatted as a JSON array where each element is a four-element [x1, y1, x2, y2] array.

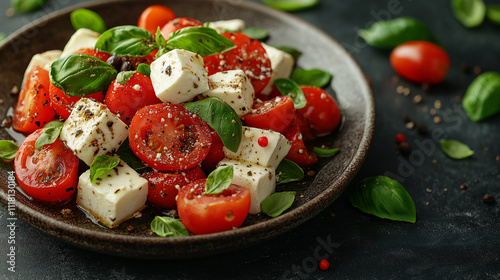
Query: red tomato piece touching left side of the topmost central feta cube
[[104, 72, 162, 125]]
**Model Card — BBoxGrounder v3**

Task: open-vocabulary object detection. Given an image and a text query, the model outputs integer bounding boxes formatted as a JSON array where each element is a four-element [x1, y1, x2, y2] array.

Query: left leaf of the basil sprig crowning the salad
[[95, 25, 158, 57]]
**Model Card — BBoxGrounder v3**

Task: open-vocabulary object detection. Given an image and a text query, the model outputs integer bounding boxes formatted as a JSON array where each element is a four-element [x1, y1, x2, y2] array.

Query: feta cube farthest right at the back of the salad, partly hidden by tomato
[[262, 43, 295, 95]]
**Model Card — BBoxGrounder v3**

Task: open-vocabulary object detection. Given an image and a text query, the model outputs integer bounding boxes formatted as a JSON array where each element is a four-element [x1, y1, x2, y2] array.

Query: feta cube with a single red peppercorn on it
[[224, 126, 292, 168]]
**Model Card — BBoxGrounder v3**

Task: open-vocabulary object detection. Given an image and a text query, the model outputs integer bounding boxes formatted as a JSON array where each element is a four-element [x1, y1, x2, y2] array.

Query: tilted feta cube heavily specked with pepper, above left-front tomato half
[[61, 98, 128, 166]]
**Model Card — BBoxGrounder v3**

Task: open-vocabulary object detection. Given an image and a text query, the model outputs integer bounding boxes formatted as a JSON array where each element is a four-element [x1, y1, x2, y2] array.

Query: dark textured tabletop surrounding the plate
[[0, 0, 500, 279]]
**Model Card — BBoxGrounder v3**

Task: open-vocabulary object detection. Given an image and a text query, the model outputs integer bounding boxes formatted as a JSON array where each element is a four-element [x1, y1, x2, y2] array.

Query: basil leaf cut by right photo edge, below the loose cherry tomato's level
[[462, 72, 500, 122]]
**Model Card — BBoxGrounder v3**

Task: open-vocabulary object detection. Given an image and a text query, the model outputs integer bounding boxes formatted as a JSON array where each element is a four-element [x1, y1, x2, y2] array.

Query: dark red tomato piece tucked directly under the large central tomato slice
[[142, 167, 206, 209]]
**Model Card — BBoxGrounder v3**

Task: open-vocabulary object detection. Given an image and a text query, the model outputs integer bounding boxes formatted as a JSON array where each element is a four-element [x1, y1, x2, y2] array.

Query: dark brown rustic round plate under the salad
[[0, 0, 375, 259]]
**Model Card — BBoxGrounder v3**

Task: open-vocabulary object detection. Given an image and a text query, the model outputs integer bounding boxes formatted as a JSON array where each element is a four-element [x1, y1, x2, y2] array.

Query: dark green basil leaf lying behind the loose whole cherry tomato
[[358, 17, 438, 49]]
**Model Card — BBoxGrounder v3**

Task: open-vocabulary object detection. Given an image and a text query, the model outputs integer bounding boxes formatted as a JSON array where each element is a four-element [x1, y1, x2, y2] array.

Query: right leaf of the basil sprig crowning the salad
[[167, 26, 236, 56]]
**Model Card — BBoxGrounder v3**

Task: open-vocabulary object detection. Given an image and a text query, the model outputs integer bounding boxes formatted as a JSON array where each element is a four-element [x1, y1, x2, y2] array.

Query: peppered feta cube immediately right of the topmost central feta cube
[[203, 70, 255, 116]]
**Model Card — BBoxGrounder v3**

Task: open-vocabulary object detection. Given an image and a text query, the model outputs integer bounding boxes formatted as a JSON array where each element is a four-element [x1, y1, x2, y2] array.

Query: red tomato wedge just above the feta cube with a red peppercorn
[[243, 96, 295, 134]]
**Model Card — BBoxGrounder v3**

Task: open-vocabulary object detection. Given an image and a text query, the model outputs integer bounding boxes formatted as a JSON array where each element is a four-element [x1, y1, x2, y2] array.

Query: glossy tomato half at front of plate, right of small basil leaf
[[177, 179, 250, 234]]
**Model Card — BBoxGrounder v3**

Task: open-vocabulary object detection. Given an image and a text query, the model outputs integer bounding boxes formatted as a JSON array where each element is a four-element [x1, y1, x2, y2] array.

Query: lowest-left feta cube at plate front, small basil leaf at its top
[[76, 161, 148, 228]]
